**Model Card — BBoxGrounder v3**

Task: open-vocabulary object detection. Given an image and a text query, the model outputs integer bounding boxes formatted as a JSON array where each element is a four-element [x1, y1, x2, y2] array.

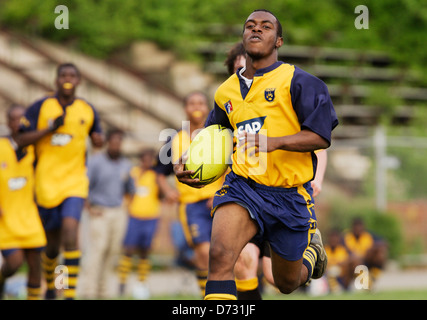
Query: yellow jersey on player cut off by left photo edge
[[0, 138, 46, 250]]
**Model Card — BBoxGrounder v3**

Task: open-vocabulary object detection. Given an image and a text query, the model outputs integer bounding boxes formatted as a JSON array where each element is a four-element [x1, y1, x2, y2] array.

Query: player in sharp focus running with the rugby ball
[[174, 10, 338, 299]]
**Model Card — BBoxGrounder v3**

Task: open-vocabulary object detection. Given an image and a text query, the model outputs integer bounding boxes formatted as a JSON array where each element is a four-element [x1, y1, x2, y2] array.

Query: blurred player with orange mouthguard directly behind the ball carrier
[[156, 92, 223, 296]]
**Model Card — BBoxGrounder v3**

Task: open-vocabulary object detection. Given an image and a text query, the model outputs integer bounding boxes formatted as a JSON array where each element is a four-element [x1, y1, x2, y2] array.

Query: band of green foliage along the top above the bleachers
[[0, 0, 427, 77]]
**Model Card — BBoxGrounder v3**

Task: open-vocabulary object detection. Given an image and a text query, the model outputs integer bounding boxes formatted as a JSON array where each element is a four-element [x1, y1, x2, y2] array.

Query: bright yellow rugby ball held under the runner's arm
[[184, 124, 233, 185]]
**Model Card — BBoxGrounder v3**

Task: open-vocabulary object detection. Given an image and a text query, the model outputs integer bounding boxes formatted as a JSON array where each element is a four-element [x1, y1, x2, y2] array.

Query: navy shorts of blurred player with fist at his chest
[[39, 197, 85, 231]]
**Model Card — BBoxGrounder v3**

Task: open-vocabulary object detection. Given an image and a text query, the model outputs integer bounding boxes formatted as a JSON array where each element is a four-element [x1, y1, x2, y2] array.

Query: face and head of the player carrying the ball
[[243, 11, 283, 60]]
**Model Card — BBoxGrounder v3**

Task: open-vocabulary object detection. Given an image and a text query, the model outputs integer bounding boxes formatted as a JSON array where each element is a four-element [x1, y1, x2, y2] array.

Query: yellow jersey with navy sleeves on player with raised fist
[[21, 96, 101, 208]]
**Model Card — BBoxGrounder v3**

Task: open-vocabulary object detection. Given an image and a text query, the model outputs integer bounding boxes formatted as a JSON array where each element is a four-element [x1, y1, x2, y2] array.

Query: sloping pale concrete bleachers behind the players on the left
[[0, 31, 185, 153]]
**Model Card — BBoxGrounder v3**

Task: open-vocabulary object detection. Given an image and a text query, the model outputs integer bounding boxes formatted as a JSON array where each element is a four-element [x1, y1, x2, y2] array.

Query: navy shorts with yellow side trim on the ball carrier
[[213, 172, 317, 261]]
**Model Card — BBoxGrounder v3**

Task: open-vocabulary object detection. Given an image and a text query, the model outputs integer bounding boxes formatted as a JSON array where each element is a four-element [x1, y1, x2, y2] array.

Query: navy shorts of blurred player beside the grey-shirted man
[[123, 217, 159, 249]]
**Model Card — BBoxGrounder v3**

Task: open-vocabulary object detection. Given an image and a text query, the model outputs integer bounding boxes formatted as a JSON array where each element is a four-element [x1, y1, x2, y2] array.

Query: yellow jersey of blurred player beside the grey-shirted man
[[129, 167, 160, 219]]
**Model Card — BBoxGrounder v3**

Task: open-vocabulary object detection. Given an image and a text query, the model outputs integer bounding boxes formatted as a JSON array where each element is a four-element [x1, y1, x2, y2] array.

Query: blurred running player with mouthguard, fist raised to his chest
[[17, 63, 103, 299]]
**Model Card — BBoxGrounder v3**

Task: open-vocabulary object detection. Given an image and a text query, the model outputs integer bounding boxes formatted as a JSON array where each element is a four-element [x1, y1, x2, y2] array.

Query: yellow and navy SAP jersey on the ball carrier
[[206, 61, 338, 188]]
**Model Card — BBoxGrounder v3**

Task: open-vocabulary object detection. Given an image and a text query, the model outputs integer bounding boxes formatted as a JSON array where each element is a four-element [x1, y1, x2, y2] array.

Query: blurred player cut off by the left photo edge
[[0, 105, 46, 300]]
